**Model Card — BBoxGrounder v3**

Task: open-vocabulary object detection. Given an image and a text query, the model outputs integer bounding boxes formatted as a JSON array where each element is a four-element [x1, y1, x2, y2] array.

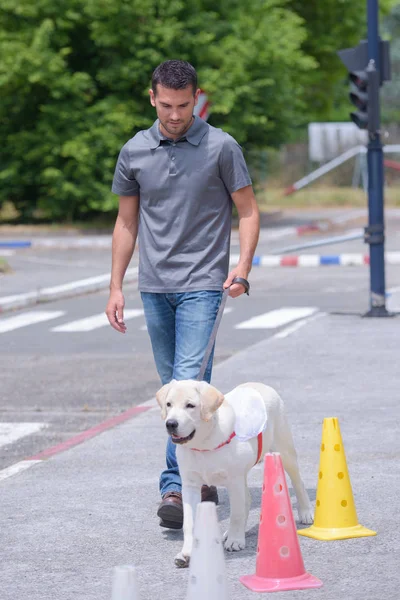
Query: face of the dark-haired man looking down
[[150, 84, 200, 139]]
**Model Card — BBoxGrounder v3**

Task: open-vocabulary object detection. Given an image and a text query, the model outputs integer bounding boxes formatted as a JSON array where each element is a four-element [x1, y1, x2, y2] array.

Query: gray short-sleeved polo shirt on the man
[[112, 117, 251, 293]]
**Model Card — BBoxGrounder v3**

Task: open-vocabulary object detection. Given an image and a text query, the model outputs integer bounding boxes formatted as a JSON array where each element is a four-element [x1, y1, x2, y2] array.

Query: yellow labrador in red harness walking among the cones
[[156, 380, 313, 567]]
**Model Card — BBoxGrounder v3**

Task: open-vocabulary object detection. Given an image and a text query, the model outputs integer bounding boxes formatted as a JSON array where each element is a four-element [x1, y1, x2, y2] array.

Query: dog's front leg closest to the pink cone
[[224, 475, 250, 552]]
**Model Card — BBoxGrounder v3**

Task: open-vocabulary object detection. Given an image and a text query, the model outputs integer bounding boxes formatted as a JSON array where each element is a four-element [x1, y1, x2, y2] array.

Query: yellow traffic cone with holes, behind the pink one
[[297, 417, 376, 541]]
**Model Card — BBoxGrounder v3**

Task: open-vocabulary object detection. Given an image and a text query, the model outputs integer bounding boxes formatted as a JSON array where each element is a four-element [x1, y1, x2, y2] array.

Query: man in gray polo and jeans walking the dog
[[106, 60, 259, 529]]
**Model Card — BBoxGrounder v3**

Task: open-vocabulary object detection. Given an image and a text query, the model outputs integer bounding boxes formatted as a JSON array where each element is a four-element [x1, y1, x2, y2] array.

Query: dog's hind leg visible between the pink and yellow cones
[[274, 414, 313, 525]]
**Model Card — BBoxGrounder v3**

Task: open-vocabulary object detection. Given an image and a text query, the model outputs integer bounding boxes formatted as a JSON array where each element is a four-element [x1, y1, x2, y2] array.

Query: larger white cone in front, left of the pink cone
[[186, 502, 229, 600]]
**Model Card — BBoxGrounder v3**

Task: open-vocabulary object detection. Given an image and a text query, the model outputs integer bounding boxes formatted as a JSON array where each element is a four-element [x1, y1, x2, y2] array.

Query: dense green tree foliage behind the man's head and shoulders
[[0, 0, 394, 220]]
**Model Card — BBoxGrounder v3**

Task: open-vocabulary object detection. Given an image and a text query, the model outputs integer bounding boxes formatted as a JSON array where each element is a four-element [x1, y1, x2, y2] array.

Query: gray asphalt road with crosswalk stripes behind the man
[[0, 258, 400, 469]]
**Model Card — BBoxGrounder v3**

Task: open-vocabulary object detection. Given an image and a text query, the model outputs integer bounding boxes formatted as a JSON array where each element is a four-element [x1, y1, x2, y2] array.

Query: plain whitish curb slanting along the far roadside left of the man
[[0, 267, 138, 313]]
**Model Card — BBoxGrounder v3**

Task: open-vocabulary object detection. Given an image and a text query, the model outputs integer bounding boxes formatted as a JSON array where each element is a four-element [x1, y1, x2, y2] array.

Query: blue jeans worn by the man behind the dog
[[141, 291, 222, 496]]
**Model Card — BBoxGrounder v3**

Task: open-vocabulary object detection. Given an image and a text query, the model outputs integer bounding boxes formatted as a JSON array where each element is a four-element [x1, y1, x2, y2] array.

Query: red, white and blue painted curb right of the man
[[230, 252, 400, 267]]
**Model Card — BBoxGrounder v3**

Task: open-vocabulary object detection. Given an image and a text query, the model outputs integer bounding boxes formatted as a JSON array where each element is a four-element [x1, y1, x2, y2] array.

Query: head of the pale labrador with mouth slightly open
[[156, 379, 224, 444]]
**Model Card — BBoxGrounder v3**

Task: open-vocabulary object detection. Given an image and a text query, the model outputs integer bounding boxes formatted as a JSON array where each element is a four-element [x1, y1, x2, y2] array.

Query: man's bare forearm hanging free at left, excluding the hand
[[110, 216, 138, 290]]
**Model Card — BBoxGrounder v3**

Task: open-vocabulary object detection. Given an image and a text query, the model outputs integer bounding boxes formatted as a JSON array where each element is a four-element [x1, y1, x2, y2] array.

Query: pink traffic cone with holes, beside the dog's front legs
[[240, 452, 322, 592]]
